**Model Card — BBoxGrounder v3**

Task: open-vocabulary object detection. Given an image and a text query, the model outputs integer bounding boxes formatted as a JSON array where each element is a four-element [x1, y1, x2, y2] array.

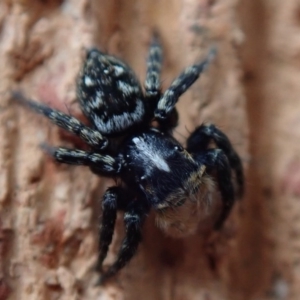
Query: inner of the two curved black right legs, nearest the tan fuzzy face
[[194, 149, 235, 230]]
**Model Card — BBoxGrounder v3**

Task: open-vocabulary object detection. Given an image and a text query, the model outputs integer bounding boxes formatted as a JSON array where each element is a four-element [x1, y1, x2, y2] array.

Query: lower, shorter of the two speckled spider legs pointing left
[[42, 144, 121, 176]]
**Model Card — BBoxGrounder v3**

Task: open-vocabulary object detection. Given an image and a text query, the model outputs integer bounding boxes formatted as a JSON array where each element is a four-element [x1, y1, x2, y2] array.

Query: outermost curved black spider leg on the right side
[[187, 124, 244, 197]]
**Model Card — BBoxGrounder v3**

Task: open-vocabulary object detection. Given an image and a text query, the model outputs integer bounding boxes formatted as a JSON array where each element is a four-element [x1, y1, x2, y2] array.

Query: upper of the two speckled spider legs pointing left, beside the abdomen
[[12, 92, 108, 149]]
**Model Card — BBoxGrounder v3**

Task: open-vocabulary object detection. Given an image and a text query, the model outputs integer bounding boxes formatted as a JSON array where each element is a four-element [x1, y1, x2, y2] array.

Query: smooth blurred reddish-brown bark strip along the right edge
[[234, 0, 300, 300]]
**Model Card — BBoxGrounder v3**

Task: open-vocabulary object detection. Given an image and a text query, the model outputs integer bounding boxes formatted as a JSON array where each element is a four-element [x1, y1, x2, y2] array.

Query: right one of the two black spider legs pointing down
[[98, 201, 149, 284]]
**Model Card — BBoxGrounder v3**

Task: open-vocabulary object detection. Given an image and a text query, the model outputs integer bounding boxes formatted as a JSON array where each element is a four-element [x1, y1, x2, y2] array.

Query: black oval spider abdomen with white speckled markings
[[77, 49, 145, 135]]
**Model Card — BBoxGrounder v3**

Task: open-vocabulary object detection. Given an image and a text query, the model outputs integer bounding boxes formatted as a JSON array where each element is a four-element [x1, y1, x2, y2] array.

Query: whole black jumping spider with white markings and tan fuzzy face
[[13, 38, 244, 283]]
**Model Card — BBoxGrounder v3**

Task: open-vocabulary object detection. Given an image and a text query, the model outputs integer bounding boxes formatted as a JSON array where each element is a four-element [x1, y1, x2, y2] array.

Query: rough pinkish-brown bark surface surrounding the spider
[[0, 0, 300, 300]]
